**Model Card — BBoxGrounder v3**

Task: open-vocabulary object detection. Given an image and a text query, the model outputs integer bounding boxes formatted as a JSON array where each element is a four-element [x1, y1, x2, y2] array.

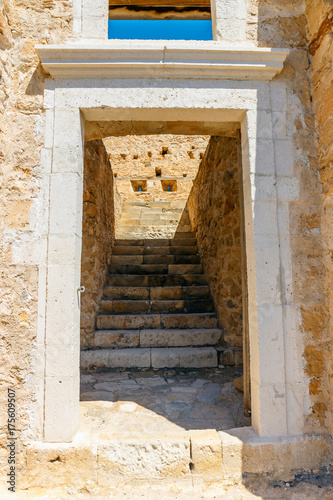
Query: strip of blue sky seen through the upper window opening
[[109, 19, 213, 40]]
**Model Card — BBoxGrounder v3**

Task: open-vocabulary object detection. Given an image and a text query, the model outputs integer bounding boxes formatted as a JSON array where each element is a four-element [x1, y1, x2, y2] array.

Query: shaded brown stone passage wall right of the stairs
[[188, 137, 243, 346]]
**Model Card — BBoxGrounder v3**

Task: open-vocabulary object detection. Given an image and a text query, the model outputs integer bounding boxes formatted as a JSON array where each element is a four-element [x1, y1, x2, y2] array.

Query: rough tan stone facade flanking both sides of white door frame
[[0, 0, 332, 451]]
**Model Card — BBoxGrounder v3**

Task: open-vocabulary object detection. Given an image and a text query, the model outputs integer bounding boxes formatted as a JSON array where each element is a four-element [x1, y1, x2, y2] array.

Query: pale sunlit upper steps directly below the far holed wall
[[116, 200, 191, 239]]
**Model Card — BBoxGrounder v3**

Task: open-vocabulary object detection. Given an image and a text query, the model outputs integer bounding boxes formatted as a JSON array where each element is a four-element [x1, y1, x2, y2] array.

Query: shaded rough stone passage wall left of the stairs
[[81, 140, 121, 348]]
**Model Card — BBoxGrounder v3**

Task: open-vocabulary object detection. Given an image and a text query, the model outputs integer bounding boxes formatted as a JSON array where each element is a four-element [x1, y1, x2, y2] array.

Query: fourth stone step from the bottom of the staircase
[[99, 299, 214, 314]]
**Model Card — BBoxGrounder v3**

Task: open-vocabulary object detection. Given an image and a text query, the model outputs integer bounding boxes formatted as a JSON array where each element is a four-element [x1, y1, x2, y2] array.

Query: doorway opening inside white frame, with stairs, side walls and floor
[[81, 124, 250, 433]]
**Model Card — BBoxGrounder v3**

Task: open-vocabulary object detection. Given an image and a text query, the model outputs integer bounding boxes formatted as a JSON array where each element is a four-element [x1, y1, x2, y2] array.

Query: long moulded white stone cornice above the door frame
[[36, 41, 289, 80]]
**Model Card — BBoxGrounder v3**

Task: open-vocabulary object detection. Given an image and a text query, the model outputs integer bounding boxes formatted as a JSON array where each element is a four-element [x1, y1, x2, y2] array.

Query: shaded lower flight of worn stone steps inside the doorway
[[81, 232, 222, 369]]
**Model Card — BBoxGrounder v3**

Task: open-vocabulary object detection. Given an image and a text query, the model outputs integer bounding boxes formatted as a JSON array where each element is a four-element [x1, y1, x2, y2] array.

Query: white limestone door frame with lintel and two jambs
[[38, 42, 303, 442]]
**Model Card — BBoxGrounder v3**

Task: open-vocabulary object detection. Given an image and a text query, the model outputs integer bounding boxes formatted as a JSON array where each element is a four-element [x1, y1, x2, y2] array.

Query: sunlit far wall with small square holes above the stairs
[[104, 134, 209, 202]]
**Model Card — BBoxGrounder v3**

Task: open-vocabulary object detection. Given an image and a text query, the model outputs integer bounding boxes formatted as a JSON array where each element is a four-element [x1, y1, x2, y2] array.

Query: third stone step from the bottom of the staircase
[[96, 313, 217, 330]]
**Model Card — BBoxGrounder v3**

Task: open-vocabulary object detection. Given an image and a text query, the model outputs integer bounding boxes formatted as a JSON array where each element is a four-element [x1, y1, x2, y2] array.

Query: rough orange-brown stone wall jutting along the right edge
[[302, 0, 333, 433]]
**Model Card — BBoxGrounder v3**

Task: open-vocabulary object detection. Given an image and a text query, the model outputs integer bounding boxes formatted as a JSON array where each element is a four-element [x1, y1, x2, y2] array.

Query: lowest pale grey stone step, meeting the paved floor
[[81, 347, 217, 370]]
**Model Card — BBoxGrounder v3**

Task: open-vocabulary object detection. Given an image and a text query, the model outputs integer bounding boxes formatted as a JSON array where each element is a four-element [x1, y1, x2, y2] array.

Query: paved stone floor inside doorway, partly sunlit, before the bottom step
[[81, 367, 251, 434]]
